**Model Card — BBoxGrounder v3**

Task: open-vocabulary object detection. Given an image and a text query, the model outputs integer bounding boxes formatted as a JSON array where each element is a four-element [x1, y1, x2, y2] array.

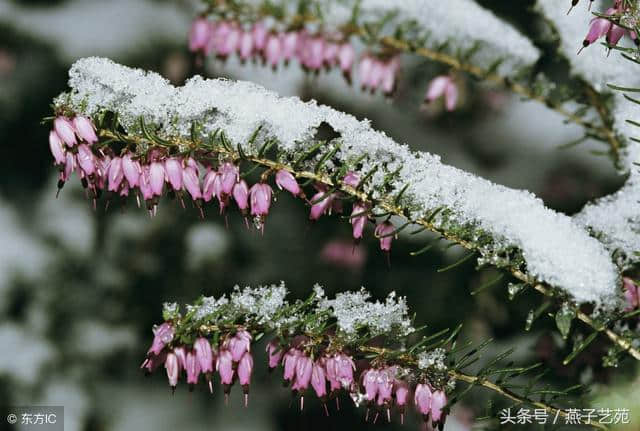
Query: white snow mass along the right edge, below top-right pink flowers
[[538, 0, 640, 269]]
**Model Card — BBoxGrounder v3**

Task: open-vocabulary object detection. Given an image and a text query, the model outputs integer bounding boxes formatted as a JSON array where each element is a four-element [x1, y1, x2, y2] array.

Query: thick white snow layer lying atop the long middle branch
[[56, 58, 618, 303]]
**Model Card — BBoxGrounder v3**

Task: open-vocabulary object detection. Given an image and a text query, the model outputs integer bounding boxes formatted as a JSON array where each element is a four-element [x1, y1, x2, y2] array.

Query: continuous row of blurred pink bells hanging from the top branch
[[189, 17, 408, 95]]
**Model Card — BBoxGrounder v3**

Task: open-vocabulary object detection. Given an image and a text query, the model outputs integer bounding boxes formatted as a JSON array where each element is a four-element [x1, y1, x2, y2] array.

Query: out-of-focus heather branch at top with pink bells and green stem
[[190, 1, 622, 162]]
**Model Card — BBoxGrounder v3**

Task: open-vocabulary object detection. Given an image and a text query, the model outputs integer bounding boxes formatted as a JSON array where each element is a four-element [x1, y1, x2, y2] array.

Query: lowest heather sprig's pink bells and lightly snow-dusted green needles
[[141, 284, 449, 426]]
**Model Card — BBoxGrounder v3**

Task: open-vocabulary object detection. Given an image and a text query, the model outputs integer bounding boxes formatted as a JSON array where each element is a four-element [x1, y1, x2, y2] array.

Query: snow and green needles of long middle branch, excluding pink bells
[[55, 58, 619, 305]]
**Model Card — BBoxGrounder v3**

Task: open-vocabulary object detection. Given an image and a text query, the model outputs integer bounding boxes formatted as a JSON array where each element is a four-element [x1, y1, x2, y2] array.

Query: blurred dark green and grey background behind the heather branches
[[0, 0, 640, 431]]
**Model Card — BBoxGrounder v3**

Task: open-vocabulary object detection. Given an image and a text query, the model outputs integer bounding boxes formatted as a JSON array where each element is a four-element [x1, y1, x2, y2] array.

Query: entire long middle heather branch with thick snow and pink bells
[[43, 59, 638, 364]]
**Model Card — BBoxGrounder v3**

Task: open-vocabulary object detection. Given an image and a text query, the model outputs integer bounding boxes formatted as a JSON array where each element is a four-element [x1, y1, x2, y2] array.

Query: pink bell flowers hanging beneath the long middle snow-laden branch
[[49, 116, 396, 252]]
